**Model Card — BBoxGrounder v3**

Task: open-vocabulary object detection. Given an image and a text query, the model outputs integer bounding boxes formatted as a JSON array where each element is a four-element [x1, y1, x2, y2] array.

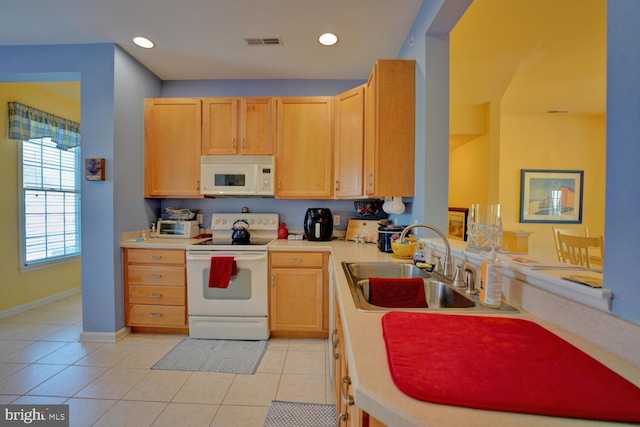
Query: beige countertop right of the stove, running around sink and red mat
[[269, 240, 640, 427]]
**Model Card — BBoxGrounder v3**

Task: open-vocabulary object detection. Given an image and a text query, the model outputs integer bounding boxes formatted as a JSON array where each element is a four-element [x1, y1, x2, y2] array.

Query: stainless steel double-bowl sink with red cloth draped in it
[[342, 262, 518, 313]]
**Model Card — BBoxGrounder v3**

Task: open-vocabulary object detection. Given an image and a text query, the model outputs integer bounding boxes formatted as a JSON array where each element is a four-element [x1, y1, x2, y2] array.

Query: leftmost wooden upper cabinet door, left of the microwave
[[144, 98, 202, 198]]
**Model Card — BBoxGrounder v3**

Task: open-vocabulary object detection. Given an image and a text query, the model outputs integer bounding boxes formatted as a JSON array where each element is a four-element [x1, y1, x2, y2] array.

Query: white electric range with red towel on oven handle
[[187, 213, 279, 340]]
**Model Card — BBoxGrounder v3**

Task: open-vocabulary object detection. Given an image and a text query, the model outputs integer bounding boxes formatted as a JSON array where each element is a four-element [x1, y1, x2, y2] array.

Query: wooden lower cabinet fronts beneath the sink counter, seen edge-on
[[331, 301, 386, 427]]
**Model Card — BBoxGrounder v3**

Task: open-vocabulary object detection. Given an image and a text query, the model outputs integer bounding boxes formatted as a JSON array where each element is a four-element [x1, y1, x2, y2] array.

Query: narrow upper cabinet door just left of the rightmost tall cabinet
[[333, 85, 364, 199]]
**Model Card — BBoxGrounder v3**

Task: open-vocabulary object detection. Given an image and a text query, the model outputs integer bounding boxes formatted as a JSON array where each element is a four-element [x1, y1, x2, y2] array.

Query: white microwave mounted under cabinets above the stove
[[200, 156, 275, 197]]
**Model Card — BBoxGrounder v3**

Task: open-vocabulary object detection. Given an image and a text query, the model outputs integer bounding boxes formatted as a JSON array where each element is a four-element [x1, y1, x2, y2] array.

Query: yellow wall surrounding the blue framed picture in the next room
[[500, 115, 606, 259]]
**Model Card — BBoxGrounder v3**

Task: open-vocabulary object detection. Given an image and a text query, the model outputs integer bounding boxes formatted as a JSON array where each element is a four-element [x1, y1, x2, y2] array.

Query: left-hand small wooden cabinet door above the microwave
[[202, 98, 238, 155]]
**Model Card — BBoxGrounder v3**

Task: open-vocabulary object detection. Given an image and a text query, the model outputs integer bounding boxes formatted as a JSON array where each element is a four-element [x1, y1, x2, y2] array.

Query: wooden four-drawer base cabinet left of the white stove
[[122, 248, 189, 334]]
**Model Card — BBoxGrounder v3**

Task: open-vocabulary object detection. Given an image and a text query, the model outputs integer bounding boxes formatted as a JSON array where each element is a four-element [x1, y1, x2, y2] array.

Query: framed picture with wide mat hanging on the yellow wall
[[520, 169, 584, 224]]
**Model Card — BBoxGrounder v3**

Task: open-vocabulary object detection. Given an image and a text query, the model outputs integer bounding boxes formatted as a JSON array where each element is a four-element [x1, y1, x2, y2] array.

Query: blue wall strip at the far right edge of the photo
[[604, 0, 640, 322]]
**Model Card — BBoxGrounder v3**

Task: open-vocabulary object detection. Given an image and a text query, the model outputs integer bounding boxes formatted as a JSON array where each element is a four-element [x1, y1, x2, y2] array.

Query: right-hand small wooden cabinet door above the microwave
[[240, 98, 274, 156]]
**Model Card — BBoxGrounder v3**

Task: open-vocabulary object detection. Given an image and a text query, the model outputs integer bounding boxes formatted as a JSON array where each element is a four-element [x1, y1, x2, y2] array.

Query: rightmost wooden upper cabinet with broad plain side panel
[[364, 59, 416, 197]]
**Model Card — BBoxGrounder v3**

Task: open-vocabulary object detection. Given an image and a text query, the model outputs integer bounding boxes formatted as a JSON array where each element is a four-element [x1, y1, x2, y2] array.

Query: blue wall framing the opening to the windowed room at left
[[0, 44, 160, 332]]
